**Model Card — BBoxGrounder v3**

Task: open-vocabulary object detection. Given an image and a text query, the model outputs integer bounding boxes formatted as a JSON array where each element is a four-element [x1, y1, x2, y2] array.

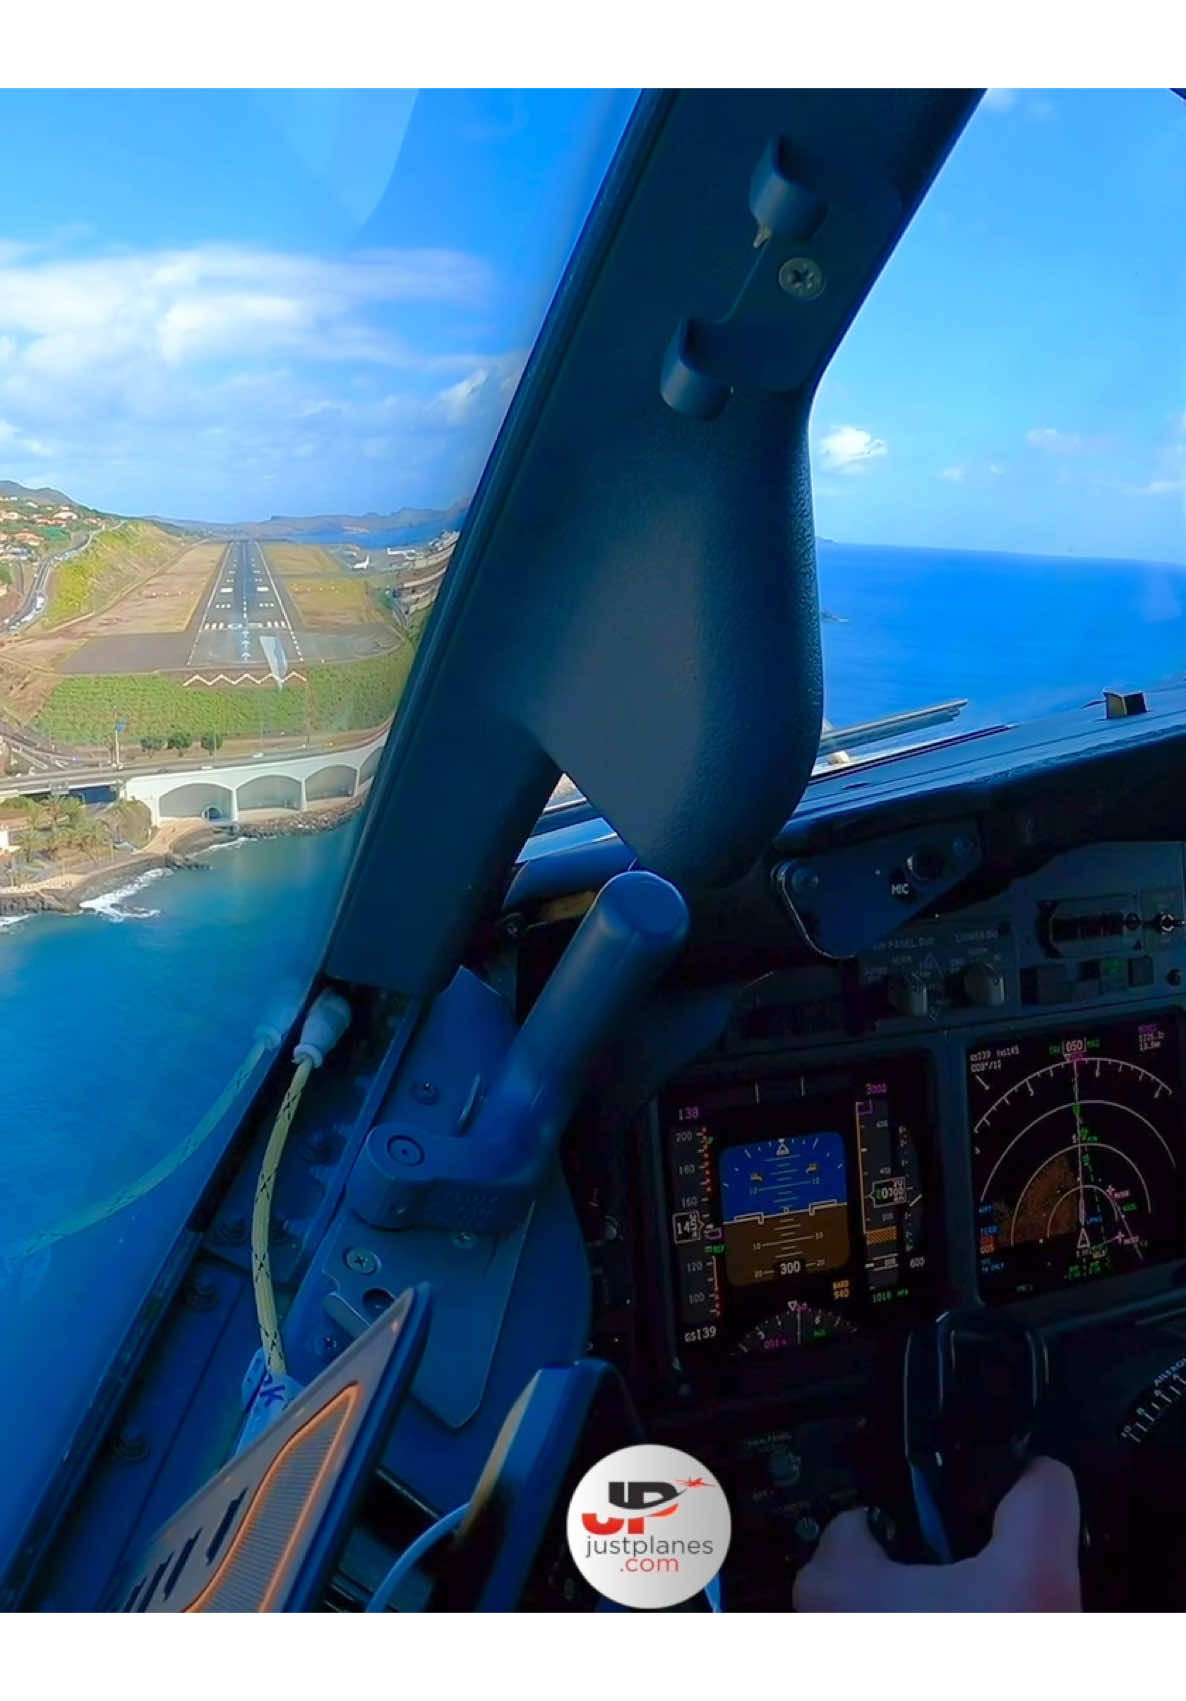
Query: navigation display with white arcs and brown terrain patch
[[968, 1015, 1186, 1300]]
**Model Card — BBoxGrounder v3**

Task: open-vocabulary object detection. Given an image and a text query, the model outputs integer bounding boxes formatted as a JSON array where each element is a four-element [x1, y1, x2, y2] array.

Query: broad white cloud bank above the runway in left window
[[0, 245, 530, 519]]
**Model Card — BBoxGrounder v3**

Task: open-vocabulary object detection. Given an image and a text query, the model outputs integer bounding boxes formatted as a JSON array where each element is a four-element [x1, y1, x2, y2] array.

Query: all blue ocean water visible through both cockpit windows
[[0, 543, 1186, 1555]]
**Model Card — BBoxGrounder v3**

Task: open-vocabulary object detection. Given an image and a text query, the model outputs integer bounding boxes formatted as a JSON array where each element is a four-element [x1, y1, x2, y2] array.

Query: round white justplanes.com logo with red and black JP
[[568, 1444, 732, 1609]]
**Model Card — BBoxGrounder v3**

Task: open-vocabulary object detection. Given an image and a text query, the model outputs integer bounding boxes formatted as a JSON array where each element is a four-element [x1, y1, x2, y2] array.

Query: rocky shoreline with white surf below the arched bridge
[[0, 788, 369, 917]]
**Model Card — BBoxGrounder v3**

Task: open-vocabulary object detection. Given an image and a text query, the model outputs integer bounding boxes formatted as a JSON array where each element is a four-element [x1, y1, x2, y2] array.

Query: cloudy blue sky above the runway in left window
[[0, 90, 633, 521]]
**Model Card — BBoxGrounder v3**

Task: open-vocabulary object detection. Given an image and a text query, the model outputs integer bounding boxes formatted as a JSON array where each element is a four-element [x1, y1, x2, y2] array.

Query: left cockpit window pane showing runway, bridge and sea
[[0, 90, 633, 1550]]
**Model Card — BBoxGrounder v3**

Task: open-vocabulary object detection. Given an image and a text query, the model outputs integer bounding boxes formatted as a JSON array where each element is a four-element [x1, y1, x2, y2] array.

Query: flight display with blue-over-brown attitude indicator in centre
[[660, 1056, 934, 1361]]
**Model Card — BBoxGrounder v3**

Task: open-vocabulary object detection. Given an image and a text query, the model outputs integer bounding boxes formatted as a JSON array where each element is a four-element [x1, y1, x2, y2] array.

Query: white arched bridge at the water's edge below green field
[[121, 737, 383, 827]]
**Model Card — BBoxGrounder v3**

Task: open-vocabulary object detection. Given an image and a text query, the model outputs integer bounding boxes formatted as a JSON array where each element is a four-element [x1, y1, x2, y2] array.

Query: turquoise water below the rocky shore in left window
[[0, 820, 359, 1555]]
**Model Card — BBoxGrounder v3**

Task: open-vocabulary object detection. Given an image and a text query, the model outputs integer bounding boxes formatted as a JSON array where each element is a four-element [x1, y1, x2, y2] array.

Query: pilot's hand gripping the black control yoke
[[795, 1458, 1082, 1613]]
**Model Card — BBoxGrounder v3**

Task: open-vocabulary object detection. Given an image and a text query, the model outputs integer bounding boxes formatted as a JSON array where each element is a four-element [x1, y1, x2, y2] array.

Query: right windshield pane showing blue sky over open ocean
[[812, 88, 1186, 765]]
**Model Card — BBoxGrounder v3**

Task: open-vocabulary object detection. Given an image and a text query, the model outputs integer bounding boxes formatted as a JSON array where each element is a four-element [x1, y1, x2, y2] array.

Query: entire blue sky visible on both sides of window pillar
[[0, 90, 1186, 563]]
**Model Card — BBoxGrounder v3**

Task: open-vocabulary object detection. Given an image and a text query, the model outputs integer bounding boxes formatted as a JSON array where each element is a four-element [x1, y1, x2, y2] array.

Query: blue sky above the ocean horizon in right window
[[812, 90, 1186, 563]]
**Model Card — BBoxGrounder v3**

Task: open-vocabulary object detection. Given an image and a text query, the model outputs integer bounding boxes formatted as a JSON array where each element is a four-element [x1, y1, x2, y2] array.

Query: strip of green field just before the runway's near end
[[34, 645, 413, 745]]
